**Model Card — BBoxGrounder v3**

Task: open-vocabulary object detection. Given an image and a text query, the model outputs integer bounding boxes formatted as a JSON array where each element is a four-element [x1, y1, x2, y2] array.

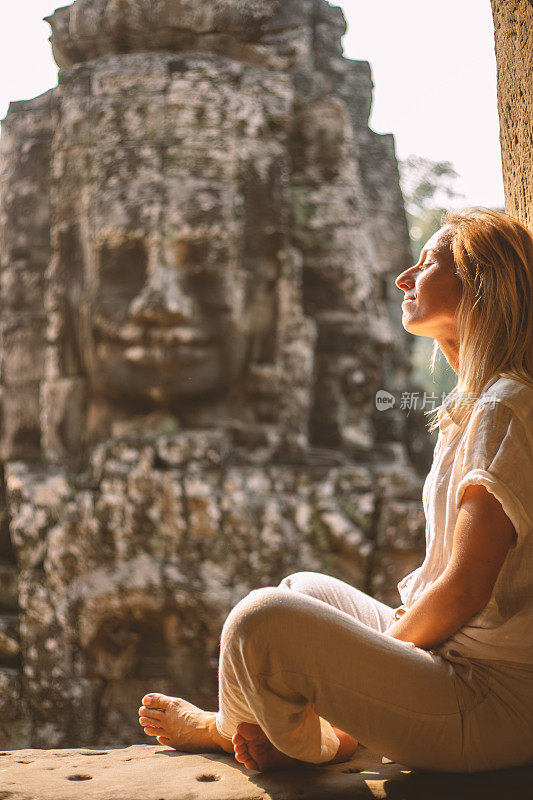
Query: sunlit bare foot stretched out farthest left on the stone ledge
[[139, 694, 233, 753]]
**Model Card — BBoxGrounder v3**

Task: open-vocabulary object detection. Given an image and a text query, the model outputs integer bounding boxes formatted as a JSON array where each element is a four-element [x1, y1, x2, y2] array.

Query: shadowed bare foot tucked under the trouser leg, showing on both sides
[[232, 722, 358, 772]]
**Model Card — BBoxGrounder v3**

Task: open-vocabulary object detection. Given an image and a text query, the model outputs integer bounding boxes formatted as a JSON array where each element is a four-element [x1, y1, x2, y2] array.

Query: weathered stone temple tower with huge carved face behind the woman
[[0, 0, 424, 748]]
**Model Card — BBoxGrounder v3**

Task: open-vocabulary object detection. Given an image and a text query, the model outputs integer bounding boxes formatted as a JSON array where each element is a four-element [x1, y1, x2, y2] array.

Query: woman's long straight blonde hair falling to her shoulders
[[426, 208, 533, 431]]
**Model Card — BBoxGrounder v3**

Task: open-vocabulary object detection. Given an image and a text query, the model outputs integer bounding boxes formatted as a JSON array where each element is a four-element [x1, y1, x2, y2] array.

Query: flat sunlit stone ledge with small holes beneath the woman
[[0, 745, 533, 800]]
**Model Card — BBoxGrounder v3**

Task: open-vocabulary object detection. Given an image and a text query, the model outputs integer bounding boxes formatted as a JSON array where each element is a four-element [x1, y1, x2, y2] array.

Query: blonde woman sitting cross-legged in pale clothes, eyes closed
[[139, 209, 533, 771]]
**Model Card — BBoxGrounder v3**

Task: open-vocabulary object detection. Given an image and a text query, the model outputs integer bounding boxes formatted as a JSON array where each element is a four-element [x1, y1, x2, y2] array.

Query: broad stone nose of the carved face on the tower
[[129, 273, 195, 326]]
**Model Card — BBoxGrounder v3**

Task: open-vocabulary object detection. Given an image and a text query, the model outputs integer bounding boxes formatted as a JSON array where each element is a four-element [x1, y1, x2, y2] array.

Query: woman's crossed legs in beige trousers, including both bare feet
[[140, 573, 461, 769]]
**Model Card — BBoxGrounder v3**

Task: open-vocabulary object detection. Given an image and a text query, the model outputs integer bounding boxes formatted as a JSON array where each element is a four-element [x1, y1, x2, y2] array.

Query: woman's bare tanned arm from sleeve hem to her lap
[[387, 485, 515, 650]]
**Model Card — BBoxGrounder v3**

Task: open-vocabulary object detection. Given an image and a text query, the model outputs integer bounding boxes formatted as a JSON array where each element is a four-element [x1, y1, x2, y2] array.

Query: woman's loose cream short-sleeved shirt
[[398, 376, 533, 664]]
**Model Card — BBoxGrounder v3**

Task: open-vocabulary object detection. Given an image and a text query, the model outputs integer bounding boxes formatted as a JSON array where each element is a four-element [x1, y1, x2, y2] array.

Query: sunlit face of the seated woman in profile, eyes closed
[[395, 226, 462, 342]]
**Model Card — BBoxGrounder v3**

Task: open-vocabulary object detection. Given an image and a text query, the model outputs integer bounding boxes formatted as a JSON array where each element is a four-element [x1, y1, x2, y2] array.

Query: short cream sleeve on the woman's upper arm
[[455, 400, 533, 544]]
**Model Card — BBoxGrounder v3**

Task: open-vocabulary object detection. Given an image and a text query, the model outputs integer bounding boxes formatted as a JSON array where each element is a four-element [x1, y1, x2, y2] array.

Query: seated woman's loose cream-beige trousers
[[217, 572, 533, 772]]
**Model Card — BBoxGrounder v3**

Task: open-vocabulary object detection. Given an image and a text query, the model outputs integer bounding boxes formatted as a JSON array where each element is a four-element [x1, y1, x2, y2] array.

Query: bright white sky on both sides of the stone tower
[[0, 0, 503, 206]]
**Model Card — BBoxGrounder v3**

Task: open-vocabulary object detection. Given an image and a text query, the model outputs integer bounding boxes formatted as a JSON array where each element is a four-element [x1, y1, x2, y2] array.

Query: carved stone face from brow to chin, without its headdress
[[65, 192, 260, 403]]
